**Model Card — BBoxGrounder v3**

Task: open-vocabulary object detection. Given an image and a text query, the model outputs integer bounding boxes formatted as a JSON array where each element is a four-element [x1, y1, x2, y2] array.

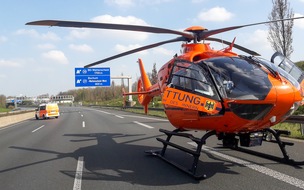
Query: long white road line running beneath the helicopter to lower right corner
[[188, 142, 304, 189]]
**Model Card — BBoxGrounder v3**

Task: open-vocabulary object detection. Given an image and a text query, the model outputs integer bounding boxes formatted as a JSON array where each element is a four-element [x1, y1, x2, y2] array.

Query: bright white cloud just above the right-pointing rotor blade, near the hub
[[198, 7, 233, 22]]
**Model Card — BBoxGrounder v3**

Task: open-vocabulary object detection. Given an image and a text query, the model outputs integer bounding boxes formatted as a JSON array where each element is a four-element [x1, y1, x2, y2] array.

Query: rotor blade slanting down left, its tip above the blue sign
[[84, 37, 188, 68]]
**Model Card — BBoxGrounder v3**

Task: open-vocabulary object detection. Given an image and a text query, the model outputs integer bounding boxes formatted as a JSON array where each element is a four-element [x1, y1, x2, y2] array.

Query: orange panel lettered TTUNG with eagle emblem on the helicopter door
[[162, 87, 221, 114]]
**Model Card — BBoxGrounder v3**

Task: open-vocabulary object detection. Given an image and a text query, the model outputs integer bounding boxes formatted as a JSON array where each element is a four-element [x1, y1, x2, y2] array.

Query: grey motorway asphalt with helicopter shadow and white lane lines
[[0, 107, 304, 190]]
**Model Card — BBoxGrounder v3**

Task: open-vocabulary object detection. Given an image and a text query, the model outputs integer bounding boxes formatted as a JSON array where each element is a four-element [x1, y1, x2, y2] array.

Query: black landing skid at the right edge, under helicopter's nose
[[232, 128, 304, 166]]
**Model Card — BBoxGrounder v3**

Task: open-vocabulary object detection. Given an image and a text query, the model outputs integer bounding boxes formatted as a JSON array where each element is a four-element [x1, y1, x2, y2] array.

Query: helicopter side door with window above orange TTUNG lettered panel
[[162, 60, 222, 116]]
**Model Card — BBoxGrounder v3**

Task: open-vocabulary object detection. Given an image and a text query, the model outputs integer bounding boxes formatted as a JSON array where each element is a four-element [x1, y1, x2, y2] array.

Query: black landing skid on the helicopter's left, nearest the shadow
[[145, 129, 216, 180]]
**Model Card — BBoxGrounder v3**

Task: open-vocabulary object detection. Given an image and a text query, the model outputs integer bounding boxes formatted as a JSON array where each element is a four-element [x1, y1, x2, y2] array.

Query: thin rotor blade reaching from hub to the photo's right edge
[[198, 16, 304, 41]]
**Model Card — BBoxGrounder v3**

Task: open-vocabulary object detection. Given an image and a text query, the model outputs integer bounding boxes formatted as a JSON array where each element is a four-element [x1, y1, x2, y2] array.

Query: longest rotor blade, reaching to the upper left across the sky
[[26, 20, 194, 40]]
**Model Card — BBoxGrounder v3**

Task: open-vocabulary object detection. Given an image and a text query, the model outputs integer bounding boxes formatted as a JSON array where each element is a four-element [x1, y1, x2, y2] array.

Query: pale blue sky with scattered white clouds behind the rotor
[[0, 0, 304, 97]]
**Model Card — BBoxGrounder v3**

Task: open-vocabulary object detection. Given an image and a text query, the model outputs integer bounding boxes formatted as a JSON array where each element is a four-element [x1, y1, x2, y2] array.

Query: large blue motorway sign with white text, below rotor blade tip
[[75, 68, 111, 87]]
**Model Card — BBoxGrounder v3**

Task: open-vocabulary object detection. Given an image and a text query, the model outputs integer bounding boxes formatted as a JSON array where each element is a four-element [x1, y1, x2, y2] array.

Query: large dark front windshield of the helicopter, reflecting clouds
[[199, 57, 272, 100]]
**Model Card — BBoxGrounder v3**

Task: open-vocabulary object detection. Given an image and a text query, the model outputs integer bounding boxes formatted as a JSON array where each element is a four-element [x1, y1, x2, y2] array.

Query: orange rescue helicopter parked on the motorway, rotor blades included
[[27, 17, 304, 178]]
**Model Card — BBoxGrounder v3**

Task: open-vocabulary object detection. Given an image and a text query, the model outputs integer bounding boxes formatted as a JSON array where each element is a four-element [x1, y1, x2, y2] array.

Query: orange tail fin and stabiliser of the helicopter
[[123, 59, 160, 114]]
